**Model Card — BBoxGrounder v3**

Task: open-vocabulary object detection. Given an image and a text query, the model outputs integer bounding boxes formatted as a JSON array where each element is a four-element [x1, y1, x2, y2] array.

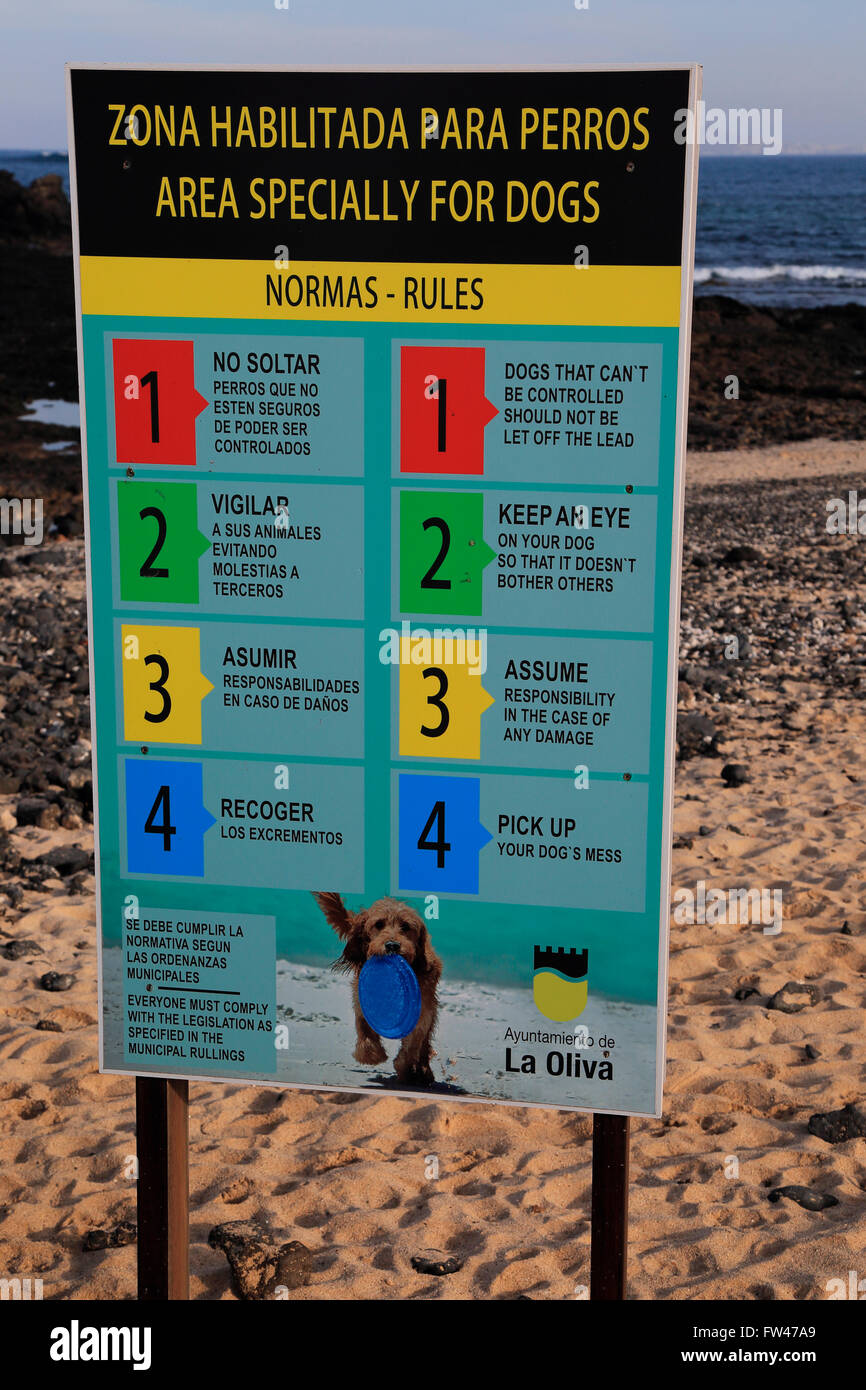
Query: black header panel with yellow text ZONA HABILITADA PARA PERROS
[[71, 68, 689, 265]]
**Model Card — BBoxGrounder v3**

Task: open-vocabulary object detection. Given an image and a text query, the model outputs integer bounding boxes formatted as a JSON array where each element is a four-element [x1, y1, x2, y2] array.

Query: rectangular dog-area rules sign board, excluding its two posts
[[68, 65, 698, 1115]]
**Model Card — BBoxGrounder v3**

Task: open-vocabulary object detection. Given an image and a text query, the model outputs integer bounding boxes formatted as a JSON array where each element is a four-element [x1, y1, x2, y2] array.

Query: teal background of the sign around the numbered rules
[[83, 309, 678, 1111]]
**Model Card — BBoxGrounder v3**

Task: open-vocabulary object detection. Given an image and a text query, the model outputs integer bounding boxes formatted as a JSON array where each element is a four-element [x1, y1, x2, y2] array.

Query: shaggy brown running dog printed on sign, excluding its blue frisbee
[[313, 892, 442, 1086]]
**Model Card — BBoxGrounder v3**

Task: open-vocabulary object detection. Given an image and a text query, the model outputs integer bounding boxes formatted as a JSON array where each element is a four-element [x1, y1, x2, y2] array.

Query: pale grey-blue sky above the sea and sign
[[0, 0, 866, 153]]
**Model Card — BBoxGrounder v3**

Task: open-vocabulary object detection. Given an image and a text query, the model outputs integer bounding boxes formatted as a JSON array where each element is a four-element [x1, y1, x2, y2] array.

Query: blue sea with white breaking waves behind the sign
[[0, 150, 866, 307]]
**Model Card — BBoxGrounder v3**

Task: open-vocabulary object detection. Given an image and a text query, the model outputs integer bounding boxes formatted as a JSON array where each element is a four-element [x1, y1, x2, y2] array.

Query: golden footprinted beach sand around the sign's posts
[[0, 441, 866, 1301]]
